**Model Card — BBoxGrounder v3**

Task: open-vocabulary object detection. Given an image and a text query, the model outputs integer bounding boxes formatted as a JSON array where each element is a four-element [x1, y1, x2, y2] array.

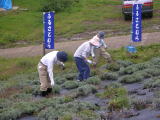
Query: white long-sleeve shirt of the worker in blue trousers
[[74, 41, 92, 58]]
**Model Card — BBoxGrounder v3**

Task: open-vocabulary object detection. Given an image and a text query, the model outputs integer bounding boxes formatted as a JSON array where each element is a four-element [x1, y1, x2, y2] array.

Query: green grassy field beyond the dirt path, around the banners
[[0, 0, 160, 48]]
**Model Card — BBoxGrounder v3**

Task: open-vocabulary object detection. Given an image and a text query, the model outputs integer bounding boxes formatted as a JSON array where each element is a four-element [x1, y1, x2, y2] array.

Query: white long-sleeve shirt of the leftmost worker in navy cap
[[40, 51, 64, 82]]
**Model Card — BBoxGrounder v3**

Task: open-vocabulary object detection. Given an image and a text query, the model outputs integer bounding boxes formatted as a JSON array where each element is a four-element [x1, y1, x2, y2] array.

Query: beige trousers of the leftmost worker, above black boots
[[37, 62, 52, 91]]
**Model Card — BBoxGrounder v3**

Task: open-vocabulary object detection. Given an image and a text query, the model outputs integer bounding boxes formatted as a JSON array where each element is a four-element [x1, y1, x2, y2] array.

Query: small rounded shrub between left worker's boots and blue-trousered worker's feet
[[62, 81, 79, 89]]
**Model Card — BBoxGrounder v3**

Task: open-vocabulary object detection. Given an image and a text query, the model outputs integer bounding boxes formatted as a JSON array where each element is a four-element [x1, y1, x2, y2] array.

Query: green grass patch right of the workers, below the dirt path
[[110, 44, 160, 63]]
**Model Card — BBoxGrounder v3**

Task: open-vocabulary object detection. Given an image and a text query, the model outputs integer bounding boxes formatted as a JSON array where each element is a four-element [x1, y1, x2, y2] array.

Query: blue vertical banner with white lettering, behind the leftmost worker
[[43, 12, 54, 49]]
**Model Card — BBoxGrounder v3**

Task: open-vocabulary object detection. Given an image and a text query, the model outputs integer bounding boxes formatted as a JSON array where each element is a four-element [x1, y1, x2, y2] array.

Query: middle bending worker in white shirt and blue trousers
[[74, 38, 99, 81]]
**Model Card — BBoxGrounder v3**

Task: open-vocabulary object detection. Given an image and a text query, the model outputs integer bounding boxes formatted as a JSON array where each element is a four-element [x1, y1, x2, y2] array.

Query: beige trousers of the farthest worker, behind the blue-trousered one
[[93, 47, 111, 63]]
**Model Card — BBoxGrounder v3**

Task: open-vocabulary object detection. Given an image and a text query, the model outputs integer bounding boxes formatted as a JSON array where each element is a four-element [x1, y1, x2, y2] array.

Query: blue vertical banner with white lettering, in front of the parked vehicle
[[132, 4, 142, 42]]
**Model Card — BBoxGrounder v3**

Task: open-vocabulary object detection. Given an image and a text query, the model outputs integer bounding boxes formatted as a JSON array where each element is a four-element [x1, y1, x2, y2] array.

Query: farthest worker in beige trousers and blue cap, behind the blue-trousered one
[[90, 32, 112, 63]]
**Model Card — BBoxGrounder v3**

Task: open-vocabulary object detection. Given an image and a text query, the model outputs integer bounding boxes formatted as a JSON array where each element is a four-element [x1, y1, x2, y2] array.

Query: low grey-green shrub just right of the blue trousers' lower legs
[[100, 72, 118, 80]]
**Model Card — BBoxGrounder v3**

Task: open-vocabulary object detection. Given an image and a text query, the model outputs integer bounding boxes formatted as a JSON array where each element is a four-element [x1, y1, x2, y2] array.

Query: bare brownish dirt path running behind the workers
[[0, 32, 160, 58]]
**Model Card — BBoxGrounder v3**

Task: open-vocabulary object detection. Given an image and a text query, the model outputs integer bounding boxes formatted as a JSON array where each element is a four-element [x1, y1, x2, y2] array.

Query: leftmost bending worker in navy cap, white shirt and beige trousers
[[37, 51, 68, 96]]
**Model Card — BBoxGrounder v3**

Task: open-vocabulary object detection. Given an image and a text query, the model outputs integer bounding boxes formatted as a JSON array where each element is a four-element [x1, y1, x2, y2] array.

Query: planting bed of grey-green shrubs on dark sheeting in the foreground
[[0, 58, 160, 120]]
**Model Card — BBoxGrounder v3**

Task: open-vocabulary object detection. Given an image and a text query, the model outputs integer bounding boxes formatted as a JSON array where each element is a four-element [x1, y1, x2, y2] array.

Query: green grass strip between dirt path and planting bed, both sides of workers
[[0, 44, 160, 80]]
